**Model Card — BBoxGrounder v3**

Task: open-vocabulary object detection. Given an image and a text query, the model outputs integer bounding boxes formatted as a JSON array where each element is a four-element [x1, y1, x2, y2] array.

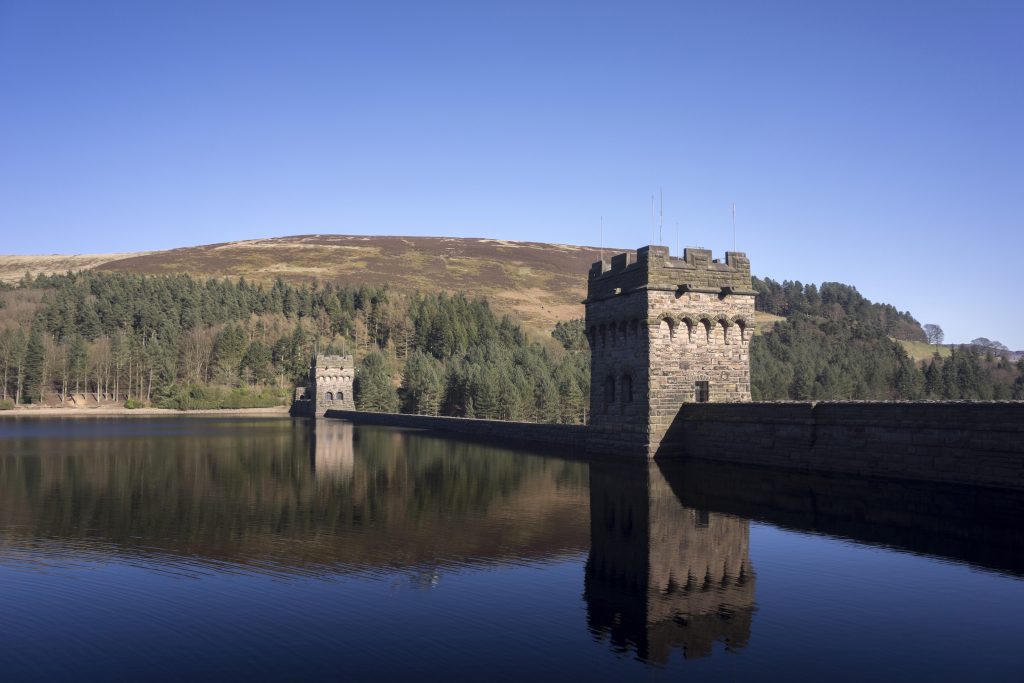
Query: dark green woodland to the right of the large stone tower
[[751, 278, 1024, 400]]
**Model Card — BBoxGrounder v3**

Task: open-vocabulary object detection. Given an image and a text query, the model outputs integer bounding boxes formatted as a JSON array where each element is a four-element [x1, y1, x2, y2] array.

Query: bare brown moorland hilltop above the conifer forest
[[0, 234, 606, 332]]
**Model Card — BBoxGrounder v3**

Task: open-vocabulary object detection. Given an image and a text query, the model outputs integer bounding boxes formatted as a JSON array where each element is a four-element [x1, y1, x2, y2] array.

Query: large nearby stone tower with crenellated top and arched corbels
[[584, 246, 756, 457]]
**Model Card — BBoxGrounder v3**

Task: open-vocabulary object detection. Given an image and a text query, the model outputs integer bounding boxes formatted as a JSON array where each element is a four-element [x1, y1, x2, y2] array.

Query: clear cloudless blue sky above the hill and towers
[[0, 0, 1024, 349]]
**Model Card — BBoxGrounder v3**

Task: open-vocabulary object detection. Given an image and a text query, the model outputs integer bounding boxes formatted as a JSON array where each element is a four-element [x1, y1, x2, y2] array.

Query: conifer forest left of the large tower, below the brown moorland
[[0, 271, 589, 422]]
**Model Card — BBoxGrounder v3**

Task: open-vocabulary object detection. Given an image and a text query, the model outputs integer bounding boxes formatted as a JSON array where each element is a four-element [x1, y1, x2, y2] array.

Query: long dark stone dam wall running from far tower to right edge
[[326, 401, 1024, 490]]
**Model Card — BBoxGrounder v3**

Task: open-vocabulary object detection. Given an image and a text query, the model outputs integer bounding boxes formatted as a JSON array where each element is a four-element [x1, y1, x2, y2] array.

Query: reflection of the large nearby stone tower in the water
[[584, 464, 756, 663]]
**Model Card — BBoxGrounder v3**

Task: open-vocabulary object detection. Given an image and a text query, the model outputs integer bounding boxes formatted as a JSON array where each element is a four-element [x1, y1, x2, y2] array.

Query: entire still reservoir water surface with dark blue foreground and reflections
[[0, 418, 1024, 681]]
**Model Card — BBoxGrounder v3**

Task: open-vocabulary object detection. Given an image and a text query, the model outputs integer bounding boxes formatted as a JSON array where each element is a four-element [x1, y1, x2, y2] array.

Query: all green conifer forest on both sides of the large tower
[[0, 270, 1024, 413]]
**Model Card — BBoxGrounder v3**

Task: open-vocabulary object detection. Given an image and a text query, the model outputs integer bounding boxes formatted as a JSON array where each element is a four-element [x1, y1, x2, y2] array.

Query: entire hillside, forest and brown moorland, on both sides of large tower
[[0, 236, 1024, 409]]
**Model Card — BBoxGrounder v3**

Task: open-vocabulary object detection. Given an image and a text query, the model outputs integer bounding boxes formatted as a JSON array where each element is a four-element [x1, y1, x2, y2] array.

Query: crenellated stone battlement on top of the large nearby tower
[[587, 245, 754, 301]]
